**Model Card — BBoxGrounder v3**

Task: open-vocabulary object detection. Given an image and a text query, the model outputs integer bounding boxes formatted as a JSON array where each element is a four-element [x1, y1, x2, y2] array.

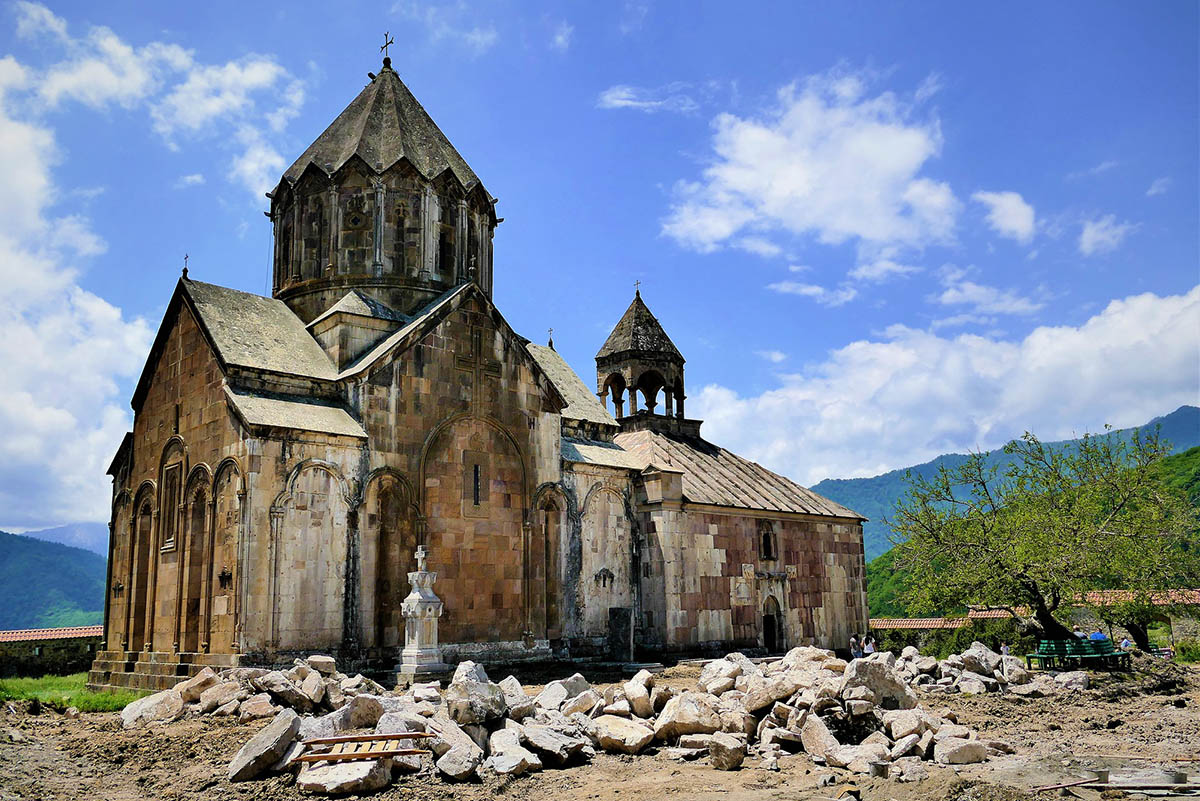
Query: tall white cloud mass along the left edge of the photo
[[0, 57, 151, 529]]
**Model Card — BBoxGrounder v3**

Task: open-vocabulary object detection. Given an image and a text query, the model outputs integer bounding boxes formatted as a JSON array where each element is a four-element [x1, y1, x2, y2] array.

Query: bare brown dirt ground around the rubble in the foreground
[[0, 660, 1200, 801]]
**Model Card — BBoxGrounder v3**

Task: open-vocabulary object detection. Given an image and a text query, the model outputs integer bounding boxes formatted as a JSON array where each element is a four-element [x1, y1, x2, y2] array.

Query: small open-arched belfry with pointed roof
[[596, 288, 686, 420]]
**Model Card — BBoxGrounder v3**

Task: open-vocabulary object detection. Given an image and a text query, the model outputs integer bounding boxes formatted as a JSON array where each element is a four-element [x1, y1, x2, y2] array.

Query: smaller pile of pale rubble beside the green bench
[[892, 642, 1087, 698]]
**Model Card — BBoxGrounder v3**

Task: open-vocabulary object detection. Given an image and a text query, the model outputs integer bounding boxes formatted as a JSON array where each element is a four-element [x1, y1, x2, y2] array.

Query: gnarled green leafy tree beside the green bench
[[892, 433, 1200, 639]]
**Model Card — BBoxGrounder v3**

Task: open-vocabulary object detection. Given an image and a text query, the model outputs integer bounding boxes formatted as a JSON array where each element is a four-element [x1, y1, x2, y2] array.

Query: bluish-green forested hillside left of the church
[[0, 531, 106, 630]]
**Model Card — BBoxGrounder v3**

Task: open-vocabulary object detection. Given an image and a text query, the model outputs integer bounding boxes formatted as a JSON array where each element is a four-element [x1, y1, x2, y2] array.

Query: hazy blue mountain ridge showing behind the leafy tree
[[810, 405, 1200, 561]]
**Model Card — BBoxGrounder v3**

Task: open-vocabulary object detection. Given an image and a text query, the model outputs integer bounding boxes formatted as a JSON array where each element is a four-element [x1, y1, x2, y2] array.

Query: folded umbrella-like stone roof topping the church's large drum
[[283, 65, 491, 191]]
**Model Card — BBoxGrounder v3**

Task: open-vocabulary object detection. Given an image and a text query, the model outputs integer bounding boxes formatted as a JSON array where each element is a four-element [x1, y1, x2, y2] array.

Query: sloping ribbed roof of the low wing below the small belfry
[[616, 430, 866, 520]]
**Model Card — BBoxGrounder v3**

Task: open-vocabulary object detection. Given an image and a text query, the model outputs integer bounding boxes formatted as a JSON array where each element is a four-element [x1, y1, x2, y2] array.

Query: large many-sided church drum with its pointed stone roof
[[268, 58, 499, 323]]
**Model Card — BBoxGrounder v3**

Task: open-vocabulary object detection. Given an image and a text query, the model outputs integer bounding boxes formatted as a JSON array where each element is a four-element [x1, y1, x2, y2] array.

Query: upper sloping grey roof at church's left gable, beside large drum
[[180, 278, 337, 381]]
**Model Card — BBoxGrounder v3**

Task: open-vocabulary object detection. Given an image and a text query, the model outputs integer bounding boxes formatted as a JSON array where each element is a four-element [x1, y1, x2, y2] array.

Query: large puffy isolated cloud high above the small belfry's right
[[662, 71, 960, 252]]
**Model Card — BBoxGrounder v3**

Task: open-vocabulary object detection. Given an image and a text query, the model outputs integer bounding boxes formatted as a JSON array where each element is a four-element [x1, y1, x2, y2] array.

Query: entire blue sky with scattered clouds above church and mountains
[[0, 0, 1200, 529]]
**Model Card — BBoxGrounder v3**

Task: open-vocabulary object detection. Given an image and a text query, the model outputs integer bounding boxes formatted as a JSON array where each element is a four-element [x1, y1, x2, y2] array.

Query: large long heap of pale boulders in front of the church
[[122, 648, 1010, 794]]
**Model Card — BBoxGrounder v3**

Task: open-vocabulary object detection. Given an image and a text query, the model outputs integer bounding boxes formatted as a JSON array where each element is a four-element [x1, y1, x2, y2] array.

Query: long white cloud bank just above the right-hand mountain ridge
[[689, 287, 1200, 484]]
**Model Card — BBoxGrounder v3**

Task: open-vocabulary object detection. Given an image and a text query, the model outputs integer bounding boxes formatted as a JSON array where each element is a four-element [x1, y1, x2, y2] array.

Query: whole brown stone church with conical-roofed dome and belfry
[[90, 59, 866, 688]]
